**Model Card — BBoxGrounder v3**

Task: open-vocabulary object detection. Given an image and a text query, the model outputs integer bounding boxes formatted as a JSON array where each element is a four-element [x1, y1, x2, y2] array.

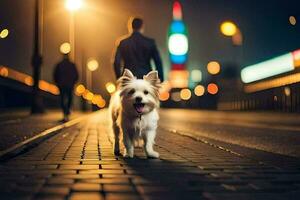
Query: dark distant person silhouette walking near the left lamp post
[[54, 54, 78, 121]]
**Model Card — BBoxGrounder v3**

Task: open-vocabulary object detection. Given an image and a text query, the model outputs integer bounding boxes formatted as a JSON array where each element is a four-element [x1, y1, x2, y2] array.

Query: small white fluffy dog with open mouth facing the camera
[[109, 69, 160, 158]]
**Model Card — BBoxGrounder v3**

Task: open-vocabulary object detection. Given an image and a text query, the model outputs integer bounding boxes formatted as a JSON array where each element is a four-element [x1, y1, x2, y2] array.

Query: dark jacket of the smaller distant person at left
[[53, 59, 78, 89]]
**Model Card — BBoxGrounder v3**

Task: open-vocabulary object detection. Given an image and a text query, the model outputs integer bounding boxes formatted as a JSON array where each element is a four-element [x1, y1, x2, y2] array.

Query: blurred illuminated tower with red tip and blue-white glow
[[168, 1, 189, 88]]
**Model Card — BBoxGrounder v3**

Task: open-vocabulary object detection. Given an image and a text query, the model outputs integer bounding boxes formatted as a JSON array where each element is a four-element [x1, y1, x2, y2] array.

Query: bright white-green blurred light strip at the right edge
[[241, 53, 294, 83]]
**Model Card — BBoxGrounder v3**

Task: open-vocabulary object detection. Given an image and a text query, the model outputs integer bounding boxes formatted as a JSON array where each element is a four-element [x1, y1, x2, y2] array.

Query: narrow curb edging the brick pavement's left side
[[0, 112, 97, 161]]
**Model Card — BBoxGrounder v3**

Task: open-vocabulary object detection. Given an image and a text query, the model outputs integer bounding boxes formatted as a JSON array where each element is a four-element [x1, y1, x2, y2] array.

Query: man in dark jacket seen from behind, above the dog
[[114, 17, 164, 81]]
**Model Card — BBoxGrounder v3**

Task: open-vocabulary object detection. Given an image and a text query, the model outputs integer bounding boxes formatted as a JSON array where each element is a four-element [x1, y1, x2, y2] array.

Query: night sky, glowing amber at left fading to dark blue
[[0, 0, 300, 95]]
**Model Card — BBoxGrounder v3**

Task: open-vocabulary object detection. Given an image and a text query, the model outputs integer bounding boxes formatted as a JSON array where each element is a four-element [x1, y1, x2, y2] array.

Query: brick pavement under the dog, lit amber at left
[[0, 112, 300, 200]]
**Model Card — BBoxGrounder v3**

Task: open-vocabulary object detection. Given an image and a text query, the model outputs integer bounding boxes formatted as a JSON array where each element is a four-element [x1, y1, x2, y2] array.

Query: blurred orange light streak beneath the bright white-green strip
[[244, 73, 300, 93]]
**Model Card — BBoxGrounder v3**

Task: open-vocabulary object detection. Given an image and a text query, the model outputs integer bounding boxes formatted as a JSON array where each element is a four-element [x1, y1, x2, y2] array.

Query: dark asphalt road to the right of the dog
[[160, 109, 300, 157]]
